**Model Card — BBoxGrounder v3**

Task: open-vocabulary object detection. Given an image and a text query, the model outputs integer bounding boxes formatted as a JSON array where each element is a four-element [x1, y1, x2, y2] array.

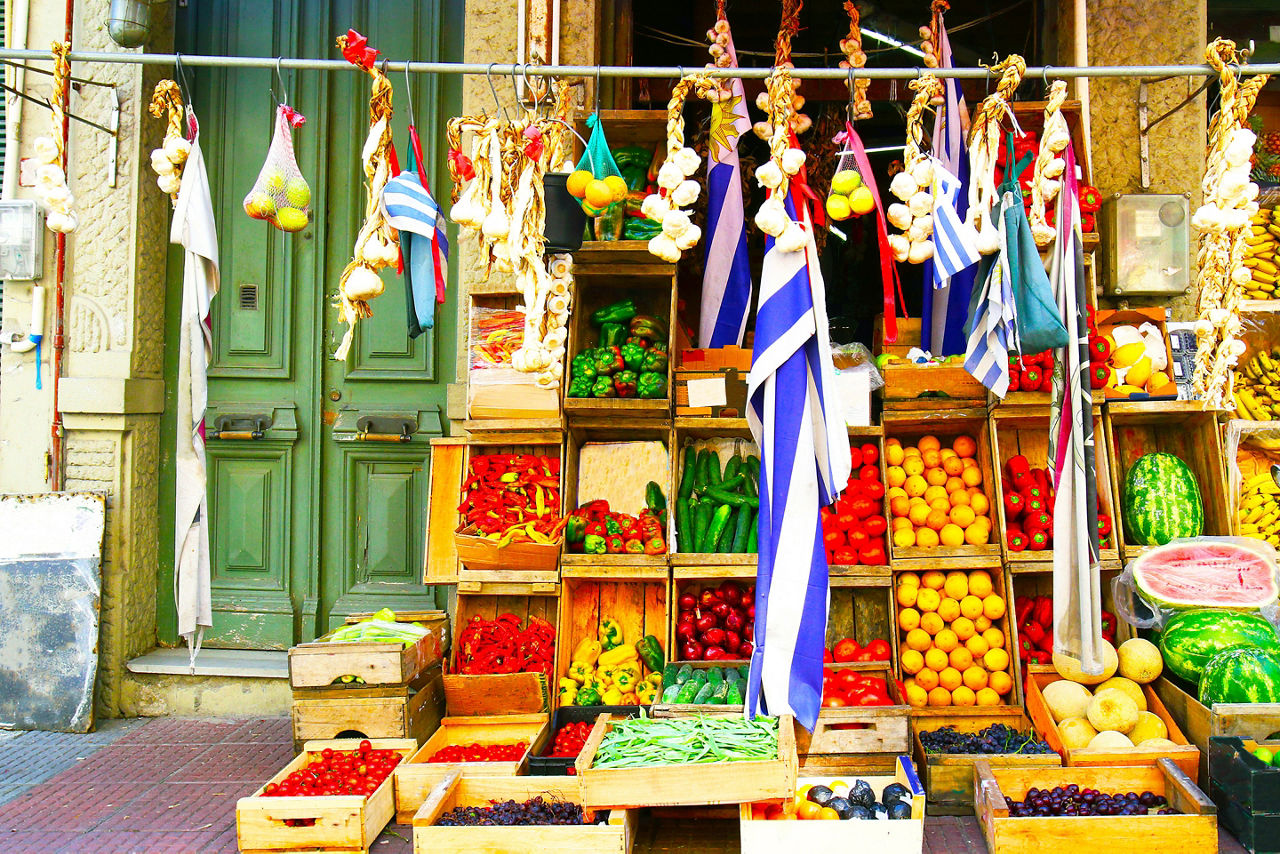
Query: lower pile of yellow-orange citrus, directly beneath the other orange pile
[[896, 570, 1014, 708]]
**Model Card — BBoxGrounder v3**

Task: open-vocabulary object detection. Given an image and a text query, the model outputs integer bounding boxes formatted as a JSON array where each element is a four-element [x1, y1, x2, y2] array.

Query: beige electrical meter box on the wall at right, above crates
[[1098, 193, 1192, 297]]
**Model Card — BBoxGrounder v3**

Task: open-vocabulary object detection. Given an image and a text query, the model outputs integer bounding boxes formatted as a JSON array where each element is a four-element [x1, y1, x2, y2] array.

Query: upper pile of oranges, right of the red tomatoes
[[884, 435, 991, 548]]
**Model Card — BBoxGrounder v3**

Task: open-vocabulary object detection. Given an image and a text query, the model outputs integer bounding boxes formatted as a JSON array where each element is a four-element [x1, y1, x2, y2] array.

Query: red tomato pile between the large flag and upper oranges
[[822, 443, 888, 566]]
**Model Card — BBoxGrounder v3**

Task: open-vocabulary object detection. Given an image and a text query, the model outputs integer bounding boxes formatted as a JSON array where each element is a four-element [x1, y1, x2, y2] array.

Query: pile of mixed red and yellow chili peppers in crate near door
[[458, 453, 564, 545]]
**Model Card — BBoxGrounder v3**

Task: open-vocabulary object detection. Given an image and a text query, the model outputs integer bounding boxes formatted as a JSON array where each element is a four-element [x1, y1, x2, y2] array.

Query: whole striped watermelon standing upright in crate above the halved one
[[1121, 453, 1204, 545]]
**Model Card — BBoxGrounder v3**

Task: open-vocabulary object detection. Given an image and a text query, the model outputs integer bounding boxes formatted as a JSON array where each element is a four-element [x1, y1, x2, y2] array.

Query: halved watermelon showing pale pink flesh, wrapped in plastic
[[1129, 538, 1280, 608]]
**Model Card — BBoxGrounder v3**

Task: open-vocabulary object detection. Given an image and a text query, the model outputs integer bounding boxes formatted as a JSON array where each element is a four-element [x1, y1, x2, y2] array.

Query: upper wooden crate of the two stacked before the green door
[[289, 615, 449, 689]]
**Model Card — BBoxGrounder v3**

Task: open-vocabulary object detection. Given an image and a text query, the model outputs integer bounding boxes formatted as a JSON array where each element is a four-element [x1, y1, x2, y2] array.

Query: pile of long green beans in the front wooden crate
[[591, 714, 778, 768]]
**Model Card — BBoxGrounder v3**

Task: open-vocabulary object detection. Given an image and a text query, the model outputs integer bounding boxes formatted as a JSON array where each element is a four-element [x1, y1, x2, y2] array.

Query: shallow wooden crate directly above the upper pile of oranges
[[873, 315, 987, 412]]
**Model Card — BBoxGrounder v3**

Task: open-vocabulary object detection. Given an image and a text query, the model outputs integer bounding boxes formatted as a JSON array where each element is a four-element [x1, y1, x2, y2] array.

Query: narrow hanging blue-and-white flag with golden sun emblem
[[698, 10, 751, 347]]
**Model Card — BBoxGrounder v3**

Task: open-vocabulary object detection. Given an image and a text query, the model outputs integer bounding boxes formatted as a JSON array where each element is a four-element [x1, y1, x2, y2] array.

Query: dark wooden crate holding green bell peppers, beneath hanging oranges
[[561, 241, 677, 425]]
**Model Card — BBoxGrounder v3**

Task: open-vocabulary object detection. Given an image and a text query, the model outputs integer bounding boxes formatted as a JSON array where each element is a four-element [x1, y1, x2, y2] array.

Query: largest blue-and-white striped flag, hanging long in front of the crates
[[746, 197, 850, 730]]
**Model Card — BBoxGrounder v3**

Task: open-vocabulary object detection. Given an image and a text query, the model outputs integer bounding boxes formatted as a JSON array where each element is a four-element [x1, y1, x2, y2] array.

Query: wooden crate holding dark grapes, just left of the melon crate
[[911, 705, 1062, 816]]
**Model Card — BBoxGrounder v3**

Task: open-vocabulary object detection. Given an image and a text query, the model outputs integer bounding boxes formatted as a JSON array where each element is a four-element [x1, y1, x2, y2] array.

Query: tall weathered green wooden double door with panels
[[160, 0, 461, 648]]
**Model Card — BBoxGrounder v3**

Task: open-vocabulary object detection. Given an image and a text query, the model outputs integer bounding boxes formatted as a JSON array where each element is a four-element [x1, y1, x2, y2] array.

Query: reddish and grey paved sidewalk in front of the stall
[[0, 717, 1244, 854]]
